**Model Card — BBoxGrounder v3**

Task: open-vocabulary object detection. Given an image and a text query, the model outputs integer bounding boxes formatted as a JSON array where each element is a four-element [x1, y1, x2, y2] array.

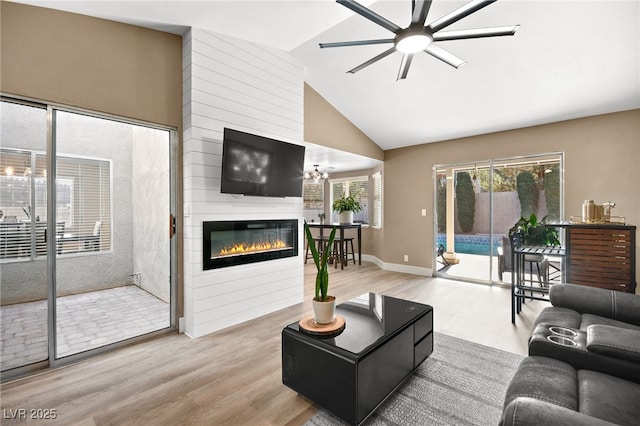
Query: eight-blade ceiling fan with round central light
[[320, 0, 519, 80]]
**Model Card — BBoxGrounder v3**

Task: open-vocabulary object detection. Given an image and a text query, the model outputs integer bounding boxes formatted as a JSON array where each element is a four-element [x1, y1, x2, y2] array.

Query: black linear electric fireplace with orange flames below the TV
[[202, 219, 298, 270]]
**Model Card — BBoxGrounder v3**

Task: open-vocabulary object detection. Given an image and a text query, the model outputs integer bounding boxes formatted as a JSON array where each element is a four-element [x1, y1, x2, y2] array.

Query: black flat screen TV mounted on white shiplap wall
[[220, 128, 305, 197]]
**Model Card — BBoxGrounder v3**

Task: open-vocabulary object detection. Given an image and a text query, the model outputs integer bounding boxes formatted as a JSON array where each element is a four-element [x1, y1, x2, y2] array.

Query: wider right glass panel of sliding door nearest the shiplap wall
[[54, 111, 171, 358]]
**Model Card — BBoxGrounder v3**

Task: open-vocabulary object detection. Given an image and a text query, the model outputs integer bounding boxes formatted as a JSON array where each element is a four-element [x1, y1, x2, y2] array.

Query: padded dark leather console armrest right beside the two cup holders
[[587, 325, 640, 363]]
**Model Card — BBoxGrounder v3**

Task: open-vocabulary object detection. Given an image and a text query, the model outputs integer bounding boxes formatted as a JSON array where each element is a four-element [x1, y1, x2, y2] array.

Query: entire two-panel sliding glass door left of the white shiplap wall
[[0, 101, 175, 376]]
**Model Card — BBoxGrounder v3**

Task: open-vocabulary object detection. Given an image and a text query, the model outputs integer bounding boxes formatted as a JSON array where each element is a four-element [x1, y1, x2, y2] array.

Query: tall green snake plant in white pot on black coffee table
[[304, 221, 336, 324]]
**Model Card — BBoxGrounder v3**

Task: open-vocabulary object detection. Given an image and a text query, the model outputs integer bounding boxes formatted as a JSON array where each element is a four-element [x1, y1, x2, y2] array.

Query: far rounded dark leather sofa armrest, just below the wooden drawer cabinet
[[549, 284, 640, 325]]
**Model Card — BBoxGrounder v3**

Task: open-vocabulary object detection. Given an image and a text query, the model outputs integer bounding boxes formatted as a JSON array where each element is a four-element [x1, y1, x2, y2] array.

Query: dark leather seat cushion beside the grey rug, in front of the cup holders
[[504, 356, 578, 411]]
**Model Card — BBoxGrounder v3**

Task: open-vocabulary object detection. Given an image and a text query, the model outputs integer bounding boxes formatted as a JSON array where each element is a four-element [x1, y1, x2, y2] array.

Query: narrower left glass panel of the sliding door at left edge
[[0, 102, 49, 371]]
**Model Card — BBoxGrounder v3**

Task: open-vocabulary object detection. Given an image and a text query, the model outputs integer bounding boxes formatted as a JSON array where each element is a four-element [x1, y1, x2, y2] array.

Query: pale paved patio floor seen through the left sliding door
[[0, 285, 170, 370]]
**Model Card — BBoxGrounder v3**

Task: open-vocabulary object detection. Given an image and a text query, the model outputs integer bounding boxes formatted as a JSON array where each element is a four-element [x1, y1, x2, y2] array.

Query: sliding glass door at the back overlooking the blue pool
[[433, 153, 563, 284]]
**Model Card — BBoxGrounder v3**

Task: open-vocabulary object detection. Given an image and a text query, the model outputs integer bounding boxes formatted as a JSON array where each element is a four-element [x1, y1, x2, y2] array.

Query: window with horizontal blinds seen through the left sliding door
[[0, 149, 111, 259]]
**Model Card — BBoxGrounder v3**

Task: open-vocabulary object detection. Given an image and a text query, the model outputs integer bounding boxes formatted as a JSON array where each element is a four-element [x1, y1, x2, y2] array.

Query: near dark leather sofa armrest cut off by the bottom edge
[[500, 397, 613, 426]]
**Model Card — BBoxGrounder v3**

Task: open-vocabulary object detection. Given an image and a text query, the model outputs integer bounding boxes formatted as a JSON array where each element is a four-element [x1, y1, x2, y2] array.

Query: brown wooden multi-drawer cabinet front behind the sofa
[[565, 224, 636, 293]]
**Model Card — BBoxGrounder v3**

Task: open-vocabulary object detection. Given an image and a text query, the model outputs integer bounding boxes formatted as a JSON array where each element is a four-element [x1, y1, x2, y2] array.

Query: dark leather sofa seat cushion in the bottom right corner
[[578, 370, 640, 425]]
